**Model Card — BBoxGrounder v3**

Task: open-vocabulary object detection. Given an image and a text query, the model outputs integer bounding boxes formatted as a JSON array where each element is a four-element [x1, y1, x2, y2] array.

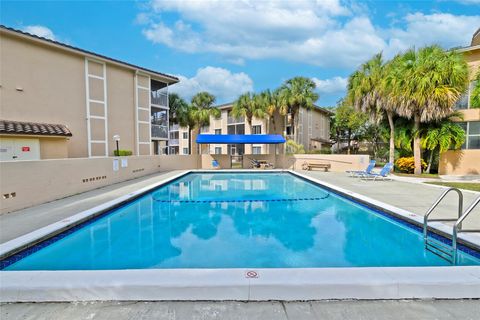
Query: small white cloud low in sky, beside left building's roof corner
[[170, 66, 253, 102]]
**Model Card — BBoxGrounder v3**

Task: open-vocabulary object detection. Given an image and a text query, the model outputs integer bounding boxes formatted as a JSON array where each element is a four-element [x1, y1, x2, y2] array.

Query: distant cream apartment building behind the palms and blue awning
[[169, 103, 331, 155]]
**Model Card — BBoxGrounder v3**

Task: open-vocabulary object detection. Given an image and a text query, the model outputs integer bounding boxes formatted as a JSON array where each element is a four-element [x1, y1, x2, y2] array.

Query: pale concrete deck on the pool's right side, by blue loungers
[[299, 171, 480, 229]]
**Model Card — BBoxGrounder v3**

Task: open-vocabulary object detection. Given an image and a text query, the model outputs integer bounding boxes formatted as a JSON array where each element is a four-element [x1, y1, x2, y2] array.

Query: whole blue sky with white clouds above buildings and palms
[[0, 0, 480, 106]]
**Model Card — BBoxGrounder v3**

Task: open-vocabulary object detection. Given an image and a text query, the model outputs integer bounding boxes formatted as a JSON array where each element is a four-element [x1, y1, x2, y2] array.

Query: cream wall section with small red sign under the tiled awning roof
[[0, 138, 40, 161]]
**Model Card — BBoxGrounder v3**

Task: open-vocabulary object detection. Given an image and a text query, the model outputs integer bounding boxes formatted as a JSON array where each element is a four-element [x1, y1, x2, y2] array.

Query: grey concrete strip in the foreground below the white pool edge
[[0, 300, 480, 320]]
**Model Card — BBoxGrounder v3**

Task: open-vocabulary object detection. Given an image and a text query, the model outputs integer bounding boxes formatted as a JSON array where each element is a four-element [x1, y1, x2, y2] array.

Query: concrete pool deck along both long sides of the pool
[[0, 170, 480, 243]]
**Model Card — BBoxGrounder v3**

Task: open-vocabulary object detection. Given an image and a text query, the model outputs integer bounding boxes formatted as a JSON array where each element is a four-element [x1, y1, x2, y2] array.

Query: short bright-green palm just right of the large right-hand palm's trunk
[[422, 119, 465, 173]]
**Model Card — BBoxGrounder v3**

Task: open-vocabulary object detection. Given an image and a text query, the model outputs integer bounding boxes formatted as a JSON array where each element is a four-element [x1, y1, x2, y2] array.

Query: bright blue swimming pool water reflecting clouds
[[1, 173, 480, 270]]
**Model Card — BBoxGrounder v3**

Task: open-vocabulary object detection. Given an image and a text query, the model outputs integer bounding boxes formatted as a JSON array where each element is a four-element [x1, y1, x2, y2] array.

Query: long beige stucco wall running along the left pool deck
[[0, 155, 199, 213]]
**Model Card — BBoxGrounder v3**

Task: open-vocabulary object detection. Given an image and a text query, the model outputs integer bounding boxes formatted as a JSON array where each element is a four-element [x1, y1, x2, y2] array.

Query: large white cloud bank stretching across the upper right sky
[[143, 0, 480, 68]]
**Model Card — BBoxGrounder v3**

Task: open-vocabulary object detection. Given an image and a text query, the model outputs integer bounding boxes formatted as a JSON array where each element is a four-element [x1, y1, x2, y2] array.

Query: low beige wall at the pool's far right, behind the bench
[[279, 154, 370, 172]]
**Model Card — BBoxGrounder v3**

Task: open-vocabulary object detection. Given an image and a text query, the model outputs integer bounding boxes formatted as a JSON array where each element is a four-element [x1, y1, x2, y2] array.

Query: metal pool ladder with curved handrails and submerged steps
[[423, 188, 480, 265]]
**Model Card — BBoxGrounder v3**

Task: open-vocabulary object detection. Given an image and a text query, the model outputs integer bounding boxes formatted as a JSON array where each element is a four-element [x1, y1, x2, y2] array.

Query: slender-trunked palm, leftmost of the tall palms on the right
[[347, 53, 395, 163]]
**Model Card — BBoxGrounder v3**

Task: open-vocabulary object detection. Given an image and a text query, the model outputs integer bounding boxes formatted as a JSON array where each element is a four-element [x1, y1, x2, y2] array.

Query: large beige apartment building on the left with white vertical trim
[[0, 26, 178, 161]]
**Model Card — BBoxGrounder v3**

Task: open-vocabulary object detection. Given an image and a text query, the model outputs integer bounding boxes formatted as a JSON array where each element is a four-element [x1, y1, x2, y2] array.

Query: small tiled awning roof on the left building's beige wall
[[0, 120, 72, 137]]
